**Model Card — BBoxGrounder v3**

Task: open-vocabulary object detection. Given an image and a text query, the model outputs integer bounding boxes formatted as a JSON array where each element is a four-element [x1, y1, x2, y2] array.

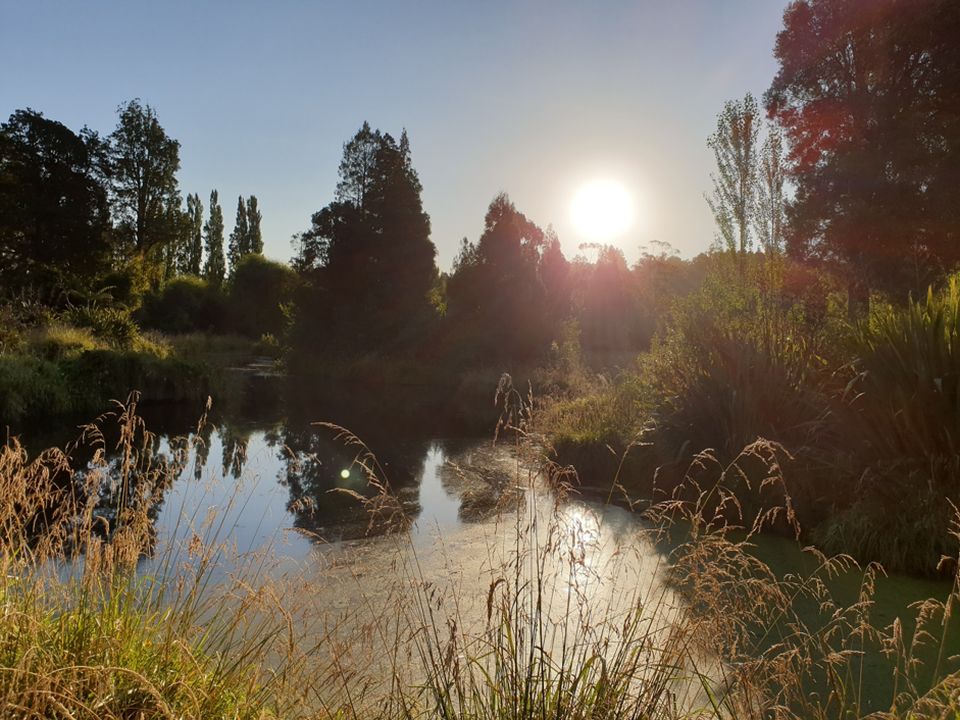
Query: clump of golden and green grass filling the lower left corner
[[0, 403, 306, 720]]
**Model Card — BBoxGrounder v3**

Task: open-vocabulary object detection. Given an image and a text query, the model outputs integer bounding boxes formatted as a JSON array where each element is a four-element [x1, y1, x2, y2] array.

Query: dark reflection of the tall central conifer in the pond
[[278, 426, 429, 541]]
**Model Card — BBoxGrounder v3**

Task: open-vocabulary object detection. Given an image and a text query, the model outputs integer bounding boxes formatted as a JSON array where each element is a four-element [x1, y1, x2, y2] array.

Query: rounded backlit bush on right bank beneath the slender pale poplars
[[647, 260, 826, 461]]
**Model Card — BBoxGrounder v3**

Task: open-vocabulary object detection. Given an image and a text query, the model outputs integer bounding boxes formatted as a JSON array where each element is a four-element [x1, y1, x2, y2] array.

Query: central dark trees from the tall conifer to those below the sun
[[293, 123, 684, 367]]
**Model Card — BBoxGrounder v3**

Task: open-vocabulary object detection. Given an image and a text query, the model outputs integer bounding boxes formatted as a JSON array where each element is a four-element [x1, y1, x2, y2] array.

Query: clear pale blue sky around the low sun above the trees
[[0, 0, 786, 270]]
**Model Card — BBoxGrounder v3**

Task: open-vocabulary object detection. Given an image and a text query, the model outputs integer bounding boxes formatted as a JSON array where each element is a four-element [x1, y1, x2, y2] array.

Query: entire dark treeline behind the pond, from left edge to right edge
[[0, 0, 960, 376]]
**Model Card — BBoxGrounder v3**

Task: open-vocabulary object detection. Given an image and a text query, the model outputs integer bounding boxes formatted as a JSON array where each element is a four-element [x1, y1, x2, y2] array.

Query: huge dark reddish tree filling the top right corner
[[766, 0, 960, 297]]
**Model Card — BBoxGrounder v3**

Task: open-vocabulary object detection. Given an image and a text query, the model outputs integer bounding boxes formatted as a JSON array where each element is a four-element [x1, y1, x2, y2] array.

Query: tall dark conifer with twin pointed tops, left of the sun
[[294, 123, 437, 351]]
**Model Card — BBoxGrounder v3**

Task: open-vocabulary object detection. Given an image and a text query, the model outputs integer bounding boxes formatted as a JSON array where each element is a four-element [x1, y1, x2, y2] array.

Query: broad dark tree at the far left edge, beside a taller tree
[[0, 110, 111, 299]]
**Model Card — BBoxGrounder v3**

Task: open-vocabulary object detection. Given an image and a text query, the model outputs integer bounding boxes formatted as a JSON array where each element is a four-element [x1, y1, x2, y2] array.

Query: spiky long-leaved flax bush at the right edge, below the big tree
[[808, 276, 960, 573]]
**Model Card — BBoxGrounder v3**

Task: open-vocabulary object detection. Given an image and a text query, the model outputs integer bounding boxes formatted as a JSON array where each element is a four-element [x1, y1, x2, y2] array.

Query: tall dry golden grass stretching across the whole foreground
[[0, 390, 960, 720]]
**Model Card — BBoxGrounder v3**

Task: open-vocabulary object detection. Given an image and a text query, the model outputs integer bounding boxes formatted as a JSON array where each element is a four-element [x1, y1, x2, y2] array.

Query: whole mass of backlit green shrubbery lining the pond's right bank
[[541, 256, 960, 573]]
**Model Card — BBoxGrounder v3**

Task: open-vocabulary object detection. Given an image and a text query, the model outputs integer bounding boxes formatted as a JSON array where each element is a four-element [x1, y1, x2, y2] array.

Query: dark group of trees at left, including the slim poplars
[[0, 100, 263, 300]]
